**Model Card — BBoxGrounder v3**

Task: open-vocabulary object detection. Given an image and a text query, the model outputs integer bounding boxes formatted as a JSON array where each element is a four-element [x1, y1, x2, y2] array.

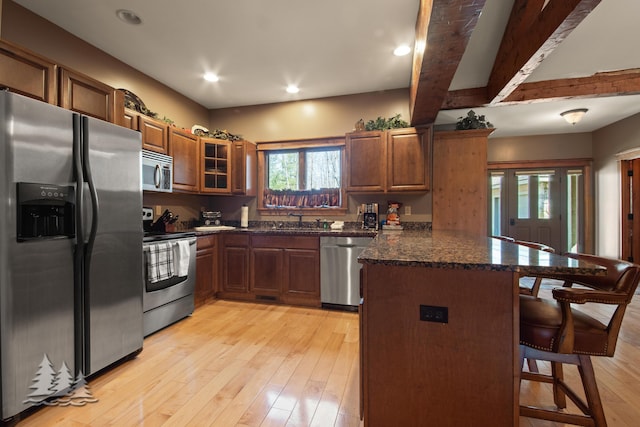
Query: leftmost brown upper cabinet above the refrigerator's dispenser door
[[0, 41, 58, 105]]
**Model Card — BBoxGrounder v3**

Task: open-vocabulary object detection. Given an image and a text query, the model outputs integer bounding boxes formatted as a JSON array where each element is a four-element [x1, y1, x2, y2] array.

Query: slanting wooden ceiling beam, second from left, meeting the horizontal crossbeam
[[487, 0, 600, 104]]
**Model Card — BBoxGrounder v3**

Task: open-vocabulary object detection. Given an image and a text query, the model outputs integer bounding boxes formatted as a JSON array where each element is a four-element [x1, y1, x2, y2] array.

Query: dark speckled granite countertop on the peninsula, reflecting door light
[[358, 231, 606, 275]]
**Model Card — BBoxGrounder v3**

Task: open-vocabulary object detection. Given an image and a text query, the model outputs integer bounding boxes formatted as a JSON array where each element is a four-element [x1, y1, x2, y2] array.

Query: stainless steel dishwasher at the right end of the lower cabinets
[[320, 236, 373, 311]]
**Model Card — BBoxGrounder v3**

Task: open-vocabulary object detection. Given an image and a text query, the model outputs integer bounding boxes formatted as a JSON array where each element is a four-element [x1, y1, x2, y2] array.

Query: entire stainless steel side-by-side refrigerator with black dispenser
[[0, 91, 143, 419]]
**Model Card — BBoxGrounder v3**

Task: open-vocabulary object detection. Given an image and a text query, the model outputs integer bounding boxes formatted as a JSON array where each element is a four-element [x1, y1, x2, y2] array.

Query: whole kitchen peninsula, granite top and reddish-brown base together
[[358, 231, 604, 427]]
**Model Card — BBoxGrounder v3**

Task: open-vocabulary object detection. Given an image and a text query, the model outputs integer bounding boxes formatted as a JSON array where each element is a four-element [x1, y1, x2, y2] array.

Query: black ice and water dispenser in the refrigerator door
[[17, 182, 75, 241]]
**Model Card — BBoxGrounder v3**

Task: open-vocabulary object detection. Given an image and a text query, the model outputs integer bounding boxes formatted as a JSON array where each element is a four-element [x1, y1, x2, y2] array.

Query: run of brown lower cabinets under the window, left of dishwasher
[[218, 233, 320, 307]]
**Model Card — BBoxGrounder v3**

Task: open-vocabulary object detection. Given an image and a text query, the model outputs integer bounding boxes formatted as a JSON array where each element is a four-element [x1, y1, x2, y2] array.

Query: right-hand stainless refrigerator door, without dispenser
[[83, 117, 143, 374]]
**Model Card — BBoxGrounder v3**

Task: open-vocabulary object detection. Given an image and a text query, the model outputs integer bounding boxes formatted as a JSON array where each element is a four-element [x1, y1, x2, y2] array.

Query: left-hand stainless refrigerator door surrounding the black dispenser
[[0, 91, 76, 419]]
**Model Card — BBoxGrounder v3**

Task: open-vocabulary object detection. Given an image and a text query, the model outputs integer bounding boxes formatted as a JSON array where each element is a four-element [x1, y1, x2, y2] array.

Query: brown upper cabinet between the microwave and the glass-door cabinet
[[169, 127, 200, 193]]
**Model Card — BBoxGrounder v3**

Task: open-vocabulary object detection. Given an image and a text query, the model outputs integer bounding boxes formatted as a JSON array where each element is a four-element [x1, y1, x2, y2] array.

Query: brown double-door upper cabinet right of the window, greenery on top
[[346, 127, 431, 192]]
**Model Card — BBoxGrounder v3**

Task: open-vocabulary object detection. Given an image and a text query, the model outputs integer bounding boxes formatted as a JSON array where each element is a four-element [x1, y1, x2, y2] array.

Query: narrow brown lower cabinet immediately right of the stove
[[194, 235, 218, 307]]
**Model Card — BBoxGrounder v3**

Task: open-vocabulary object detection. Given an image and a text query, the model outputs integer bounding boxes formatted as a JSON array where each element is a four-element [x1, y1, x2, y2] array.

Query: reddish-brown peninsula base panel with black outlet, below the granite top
[[360, 263, 519, 427]]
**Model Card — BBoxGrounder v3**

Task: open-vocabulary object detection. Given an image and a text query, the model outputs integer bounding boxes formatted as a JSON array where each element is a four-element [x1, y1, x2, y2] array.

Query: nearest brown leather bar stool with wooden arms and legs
[[520, 254, 640, 427]]
